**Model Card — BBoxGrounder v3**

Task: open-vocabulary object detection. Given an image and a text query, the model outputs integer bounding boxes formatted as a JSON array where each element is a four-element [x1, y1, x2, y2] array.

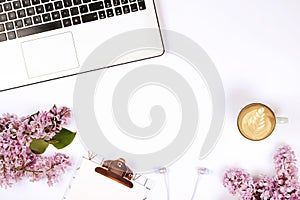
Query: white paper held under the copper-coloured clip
[[64, 154, 153, 200]]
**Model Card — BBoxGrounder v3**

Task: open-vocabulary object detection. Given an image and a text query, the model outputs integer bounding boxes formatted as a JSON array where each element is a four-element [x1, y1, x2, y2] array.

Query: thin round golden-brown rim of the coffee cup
[[237, 103, 276, 141]]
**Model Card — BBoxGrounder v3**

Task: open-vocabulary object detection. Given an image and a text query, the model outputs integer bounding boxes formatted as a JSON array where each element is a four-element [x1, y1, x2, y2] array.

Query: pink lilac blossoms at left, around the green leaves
[[0, 106, 71, 188]]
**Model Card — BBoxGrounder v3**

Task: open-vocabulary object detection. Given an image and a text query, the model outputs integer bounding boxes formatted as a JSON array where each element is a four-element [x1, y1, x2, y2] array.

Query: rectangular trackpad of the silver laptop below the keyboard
[[22, 32, 79, 78]]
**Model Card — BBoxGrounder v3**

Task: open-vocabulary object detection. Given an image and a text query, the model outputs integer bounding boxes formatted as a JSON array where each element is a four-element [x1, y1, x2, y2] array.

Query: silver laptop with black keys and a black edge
[[0, 0, 164, 91]]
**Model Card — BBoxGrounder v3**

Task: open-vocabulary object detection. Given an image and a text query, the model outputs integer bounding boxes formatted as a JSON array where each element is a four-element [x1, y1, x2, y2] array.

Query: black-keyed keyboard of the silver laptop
[[0, 0, 146, 42]]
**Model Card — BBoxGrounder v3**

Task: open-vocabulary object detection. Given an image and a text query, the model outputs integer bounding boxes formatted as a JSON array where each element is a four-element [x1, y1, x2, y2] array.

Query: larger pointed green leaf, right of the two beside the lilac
[[49, 128, 76, 149]]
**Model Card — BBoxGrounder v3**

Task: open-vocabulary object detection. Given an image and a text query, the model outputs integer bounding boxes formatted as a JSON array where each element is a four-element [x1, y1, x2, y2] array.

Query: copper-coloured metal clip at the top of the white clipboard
[[95, 158, 133, 188]]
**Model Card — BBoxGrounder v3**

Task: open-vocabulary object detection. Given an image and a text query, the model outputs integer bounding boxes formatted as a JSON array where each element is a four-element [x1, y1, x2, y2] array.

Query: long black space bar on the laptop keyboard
[[17, 21, 62, 37]]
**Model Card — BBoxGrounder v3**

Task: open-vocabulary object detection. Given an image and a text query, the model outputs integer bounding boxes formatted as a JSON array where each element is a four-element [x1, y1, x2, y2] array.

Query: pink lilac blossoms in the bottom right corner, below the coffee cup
[[223, 146, 300, 200]]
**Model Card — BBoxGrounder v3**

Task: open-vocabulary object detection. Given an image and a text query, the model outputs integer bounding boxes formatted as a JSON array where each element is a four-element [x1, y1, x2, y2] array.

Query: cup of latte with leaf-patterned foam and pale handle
[[237, 103, 288, 141]]
